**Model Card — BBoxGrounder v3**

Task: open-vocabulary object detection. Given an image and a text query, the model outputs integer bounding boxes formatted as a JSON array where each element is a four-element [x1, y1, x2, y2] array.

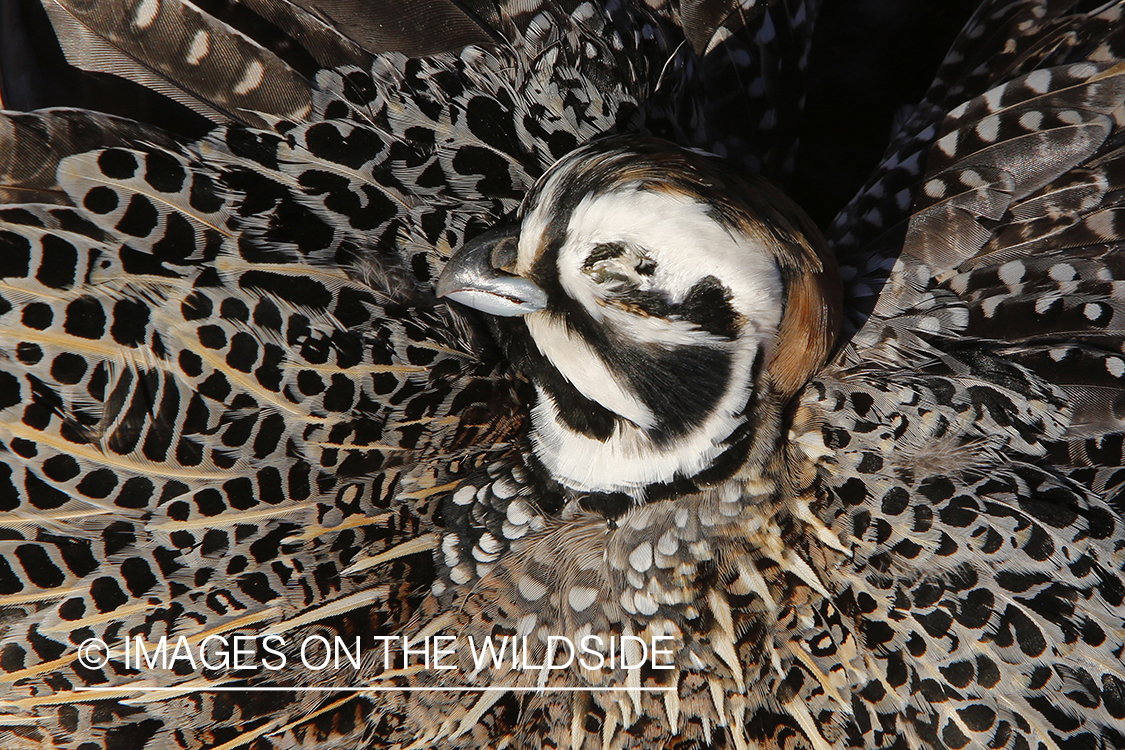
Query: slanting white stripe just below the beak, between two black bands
[[523, 313, 656, 430]]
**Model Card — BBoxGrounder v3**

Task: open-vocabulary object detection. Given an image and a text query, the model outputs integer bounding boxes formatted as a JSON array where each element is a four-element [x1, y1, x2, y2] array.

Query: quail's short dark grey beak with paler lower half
[[437, 227, 547, 317]]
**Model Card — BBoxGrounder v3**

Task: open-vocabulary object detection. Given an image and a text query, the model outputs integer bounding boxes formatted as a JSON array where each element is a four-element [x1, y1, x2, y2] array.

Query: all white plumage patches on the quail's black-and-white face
[[521, 183, 783, 495]]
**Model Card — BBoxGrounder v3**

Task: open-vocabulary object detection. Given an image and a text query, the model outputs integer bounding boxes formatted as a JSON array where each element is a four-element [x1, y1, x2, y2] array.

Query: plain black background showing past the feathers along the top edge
[[0, 0, 980, 226]]
